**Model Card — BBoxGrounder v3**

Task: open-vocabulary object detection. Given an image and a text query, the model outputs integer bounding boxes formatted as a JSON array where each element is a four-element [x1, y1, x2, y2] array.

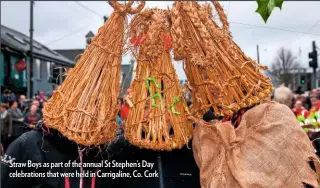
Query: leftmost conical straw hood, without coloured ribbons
[[44, 1, 145, 146]]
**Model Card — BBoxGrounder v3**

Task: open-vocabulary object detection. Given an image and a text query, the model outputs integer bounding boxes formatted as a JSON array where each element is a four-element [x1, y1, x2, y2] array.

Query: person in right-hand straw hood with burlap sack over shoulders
[[172, 1, 320, 188]]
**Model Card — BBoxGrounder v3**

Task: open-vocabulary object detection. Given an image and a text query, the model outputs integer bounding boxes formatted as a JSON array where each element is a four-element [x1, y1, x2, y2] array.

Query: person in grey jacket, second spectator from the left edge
[[8, 101, 25, 145]]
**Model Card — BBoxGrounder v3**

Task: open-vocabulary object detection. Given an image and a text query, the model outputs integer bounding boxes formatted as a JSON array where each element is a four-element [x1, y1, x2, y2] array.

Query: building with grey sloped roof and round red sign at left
[[0, 25, 74, 96]]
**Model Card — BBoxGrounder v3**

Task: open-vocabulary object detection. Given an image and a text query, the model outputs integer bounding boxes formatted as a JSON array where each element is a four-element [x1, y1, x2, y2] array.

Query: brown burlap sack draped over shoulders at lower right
[[193, 102, 320, 188]]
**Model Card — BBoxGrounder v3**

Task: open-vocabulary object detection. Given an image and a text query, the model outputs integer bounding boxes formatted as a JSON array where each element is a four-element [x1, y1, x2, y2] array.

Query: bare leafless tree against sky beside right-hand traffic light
[[271, 47, 300, 86]]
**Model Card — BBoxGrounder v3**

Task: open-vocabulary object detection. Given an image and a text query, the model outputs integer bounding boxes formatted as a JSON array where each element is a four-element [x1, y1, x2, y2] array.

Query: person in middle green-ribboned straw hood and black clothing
[[102, 9, 200, 188]]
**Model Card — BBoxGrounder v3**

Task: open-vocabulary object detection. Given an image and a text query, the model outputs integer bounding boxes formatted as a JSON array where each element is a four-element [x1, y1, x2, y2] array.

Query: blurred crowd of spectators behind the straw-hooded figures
[[0, 86, 320, 152]]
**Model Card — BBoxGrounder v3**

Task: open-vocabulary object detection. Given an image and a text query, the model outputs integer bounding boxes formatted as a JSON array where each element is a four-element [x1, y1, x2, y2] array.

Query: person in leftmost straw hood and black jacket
[[1, 1, 145, 188]]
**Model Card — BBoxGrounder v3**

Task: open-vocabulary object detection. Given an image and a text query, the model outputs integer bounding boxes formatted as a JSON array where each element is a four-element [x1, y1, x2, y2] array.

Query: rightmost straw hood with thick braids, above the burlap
[[171, 1, 273, 117]]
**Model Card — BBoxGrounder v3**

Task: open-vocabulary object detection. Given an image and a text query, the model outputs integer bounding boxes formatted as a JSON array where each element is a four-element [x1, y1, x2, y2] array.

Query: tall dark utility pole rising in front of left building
[[27, 0, 34, 99]]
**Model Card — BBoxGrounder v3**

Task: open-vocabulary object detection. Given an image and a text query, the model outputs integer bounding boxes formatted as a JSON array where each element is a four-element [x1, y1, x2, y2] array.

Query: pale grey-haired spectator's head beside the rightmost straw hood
[[274, 86, 294, 108]]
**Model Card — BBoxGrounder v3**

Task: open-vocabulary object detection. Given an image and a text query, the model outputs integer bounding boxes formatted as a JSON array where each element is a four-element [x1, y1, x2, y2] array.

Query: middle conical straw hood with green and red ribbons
[[125, 9, 192, 151]]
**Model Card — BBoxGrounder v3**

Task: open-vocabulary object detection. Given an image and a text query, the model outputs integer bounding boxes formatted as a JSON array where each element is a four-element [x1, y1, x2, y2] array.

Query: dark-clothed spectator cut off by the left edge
[[0, 103, 12, 151]]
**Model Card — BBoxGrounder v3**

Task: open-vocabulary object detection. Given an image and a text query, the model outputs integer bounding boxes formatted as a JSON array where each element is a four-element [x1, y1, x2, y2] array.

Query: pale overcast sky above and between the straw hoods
[[1, 1, 320, 79]]
